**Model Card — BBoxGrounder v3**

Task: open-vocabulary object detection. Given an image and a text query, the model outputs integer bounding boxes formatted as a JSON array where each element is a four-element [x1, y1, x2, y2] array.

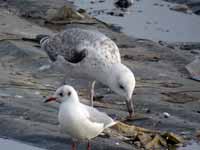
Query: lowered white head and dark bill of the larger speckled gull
[[108, 64, 135, 115]]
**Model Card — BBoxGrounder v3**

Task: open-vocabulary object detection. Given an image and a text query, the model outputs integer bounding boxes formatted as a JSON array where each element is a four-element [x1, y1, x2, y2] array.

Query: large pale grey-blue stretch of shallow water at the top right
[[74, 0, 200, 42]]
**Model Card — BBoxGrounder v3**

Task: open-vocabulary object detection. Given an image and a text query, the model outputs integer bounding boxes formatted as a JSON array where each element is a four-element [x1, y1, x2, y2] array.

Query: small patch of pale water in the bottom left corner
[[0, 138, 45, 150]]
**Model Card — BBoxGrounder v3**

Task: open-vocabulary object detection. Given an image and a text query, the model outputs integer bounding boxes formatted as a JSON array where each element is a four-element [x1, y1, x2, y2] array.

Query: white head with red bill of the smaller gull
[[45, 85, 79, 103]]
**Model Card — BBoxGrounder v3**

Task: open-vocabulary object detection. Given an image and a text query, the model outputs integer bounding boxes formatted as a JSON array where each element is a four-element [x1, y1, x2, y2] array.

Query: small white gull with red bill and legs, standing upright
[[45, 85, 117, 150]]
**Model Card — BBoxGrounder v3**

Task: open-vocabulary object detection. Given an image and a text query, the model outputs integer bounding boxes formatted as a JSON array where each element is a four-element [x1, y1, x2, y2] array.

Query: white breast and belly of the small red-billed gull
[[58, 102, 104, 140]]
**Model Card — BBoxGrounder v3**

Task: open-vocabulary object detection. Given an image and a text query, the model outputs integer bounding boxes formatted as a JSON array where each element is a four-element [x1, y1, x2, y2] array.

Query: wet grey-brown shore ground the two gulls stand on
[[0, 0, 200, 150]]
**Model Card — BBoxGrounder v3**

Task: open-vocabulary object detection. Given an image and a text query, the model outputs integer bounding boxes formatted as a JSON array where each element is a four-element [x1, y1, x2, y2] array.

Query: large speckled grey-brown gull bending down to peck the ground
[[40, 28, 135, 117]]
